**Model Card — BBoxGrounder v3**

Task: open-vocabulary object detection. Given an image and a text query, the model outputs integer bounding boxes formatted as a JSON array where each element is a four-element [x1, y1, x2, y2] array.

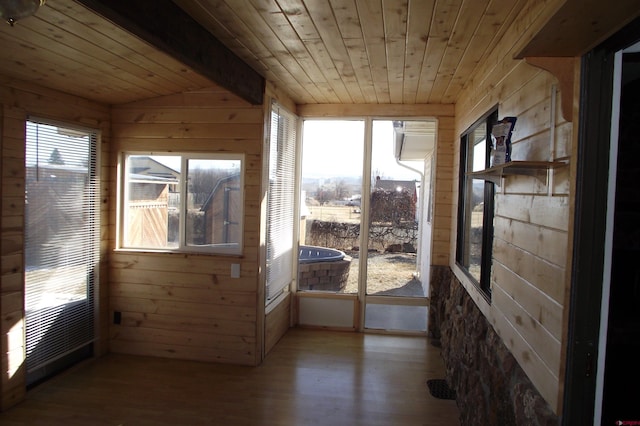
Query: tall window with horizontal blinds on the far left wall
[[25, 121, 100, 383]]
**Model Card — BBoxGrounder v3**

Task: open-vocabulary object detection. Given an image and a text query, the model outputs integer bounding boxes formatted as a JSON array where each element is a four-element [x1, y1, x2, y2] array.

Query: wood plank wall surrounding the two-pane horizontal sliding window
[[110, 87, 264, 365]]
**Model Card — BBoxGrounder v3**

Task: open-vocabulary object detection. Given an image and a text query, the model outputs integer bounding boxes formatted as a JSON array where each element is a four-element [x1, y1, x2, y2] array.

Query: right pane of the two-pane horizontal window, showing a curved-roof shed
[[185, 159, 242, 247]]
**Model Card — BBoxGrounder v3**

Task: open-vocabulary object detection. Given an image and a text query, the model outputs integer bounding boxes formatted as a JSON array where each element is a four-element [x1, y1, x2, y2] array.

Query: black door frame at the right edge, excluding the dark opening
[[562, 19, 640, 425]]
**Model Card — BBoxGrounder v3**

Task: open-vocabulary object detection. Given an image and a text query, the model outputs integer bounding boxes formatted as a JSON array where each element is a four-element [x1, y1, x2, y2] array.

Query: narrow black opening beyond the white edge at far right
[[602, 49, 640, 425]]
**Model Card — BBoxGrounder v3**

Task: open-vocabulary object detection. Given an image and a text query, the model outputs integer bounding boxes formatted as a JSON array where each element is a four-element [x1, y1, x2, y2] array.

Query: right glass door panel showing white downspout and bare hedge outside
[[365, 120, 435, 331]]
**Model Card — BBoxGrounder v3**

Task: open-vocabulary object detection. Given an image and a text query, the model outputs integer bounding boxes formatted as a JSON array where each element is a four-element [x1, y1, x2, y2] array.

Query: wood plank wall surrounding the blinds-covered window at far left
[[0, 77, 110, 410]]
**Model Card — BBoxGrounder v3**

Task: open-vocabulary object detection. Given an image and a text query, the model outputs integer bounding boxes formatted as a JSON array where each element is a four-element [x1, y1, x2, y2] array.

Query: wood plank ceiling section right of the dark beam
[[174, 0, 525, 104]]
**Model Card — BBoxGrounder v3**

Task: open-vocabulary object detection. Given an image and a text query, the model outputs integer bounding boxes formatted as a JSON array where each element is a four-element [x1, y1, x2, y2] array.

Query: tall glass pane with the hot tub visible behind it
[[298, 120, 364, 293]]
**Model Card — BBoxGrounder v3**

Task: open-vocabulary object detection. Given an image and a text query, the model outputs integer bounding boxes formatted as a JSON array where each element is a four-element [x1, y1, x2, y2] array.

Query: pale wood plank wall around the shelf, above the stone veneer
[[450, 4, 574, 413]]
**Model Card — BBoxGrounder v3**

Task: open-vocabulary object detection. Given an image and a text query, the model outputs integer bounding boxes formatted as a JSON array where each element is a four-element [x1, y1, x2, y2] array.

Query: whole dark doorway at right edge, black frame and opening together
[[562, 19, 640, 425]]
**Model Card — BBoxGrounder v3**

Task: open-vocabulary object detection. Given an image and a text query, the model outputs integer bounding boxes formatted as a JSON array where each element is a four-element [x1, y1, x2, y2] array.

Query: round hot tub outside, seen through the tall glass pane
[[298, 246, 351, 291]]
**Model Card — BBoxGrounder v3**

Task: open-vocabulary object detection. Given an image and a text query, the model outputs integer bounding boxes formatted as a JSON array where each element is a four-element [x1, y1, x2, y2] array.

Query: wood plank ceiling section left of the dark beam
[[0, 0, 211, 104]]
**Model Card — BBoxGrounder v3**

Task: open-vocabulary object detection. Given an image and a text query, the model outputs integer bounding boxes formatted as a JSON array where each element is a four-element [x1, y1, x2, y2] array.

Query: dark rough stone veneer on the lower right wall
[[429, 266, 560, 426]]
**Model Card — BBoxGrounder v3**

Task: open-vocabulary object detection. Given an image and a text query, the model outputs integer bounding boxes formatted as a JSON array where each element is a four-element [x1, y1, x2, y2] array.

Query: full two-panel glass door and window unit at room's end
[[298, 119, 436, 333]]
